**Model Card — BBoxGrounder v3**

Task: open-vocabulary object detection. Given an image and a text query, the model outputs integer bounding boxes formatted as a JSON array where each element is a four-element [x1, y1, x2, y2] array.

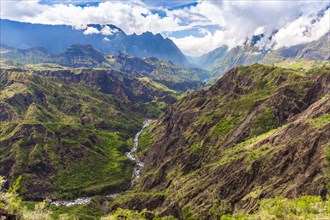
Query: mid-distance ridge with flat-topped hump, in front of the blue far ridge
[[0, 44, 209, 92]]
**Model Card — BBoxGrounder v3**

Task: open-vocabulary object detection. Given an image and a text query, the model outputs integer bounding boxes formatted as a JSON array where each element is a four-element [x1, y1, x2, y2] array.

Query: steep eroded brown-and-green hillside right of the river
[[110, 64, 330, 219]]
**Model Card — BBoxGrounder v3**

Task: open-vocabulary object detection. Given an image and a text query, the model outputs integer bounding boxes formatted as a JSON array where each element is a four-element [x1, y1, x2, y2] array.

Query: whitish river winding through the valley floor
[[52, 119, 152, 206]]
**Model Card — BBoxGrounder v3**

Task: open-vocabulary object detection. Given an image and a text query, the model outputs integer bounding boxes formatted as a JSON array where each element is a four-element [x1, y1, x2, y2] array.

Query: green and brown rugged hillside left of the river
[[0, 68, 183, 200]]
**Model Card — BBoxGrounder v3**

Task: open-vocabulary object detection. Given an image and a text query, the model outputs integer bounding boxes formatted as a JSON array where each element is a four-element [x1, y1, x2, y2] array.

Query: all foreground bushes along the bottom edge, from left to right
[[0, 174, 330, 220]]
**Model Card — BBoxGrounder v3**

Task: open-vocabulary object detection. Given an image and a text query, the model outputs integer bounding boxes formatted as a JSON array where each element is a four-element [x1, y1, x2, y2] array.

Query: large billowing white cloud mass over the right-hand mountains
[[171, 1, 330, 56]]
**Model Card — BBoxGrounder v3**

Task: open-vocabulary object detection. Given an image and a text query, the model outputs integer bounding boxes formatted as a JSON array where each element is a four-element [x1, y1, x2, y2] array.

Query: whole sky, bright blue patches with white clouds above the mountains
[[0, 0, 330, 56]]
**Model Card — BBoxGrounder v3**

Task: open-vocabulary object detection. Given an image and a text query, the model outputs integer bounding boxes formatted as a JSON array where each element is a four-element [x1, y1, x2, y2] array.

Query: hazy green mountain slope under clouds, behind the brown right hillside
[[196, 33, 330, 78]]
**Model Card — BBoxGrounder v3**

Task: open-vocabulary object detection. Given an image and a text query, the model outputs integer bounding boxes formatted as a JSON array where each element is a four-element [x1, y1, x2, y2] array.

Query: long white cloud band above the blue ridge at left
[[0, 0, 189, 34]]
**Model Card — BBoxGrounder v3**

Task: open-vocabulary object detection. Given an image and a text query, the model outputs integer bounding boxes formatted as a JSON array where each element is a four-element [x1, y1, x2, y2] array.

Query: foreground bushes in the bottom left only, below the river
[[0, 176, 176, 220]]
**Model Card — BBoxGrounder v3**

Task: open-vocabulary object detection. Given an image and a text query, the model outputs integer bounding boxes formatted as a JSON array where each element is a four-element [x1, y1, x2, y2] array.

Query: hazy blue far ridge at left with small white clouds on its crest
[[0, 19, 187, 65]]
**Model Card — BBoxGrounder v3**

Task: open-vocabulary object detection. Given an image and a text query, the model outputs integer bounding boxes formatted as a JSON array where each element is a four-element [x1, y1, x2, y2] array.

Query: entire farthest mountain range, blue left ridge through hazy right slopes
[[0, 19, 330, 78]]
